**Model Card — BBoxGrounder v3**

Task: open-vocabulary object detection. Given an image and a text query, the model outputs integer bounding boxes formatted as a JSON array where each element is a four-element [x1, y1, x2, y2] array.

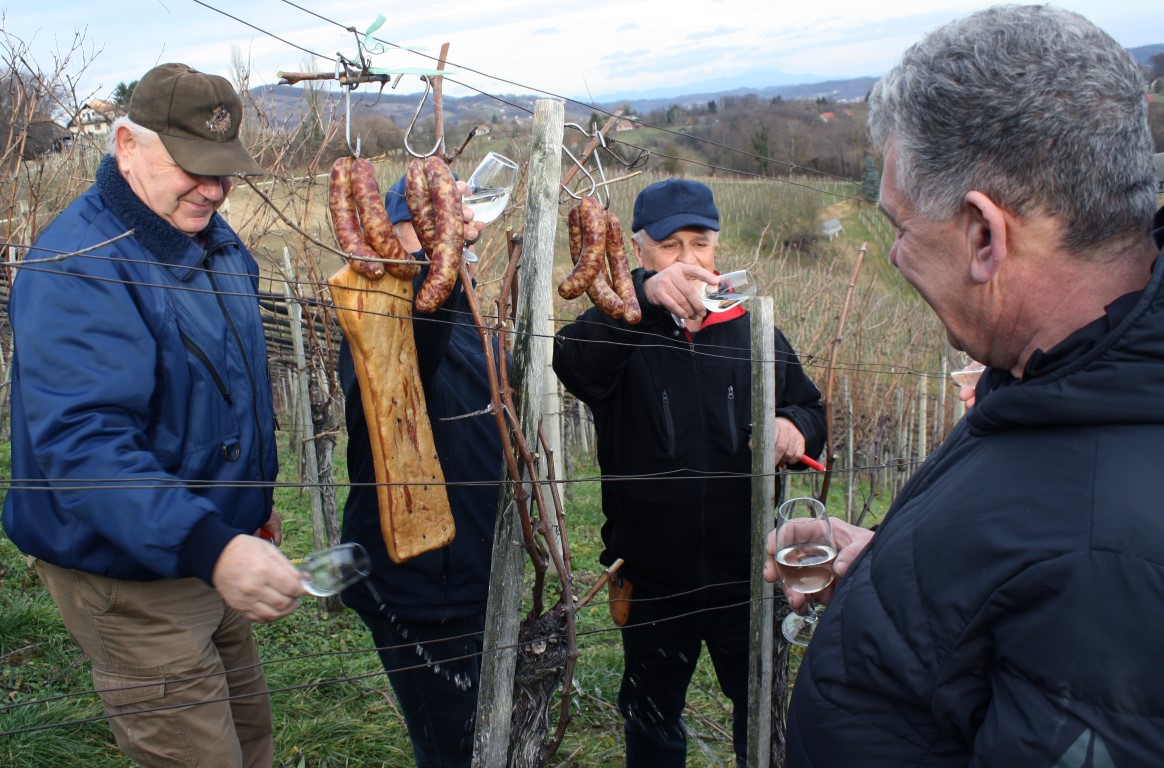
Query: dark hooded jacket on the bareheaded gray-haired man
[[788, 224, 1164, 768]]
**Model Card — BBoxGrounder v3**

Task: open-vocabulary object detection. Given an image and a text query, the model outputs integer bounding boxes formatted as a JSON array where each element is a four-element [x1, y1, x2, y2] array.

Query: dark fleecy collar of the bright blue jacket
[[97, 155, 239, 280]]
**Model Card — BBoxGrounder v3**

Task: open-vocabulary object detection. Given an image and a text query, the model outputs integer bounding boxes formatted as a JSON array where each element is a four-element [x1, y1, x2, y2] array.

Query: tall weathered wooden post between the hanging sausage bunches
[[473, 99, 565, 768]]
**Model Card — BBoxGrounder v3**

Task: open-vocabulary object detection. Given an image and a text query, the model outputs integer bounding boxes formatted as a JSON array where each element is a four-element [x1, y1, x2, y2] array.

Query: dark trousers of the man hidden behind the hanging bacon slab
[[360, 609, 485, 768]]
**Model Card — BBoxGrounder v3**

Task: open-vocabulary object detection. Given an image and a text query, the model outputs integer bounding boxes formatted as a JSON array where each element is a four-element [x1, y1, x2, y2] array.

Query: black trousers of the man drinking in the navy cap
[[618, 595, 748, 768]]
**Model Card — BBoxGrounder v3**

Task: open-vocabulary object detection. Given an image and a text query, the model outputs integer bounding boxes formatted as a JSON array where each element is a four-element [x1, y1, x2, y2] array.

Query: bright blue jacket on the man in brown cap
[[3, 157, 277, 583]]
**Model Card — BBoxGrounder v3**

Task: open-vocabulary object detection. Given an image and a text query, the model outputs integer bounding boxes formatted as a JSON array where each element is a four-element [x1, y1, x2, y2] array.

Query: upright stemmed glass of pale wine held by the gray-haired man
[[775, 497, 837, 646]]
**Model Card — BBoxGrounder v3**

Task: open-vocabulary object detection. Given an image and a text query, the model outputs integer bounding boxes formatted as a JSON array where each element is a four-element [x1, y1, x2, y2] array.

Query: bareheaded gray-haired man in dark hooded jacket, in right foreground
[[766, 6, 1164, 768]]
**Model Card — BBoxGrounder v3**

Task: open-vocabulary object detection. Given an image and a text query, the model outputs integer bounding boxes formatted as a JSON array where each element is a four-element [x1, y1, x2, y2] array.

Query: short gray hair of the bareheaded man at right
[[868, 6, 1156, 256]]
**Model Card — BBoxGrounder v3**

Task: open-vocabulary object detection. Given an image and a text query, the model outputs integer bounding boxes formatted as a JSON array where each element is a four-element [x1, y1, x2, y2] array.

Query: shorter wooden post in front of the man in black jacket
[[747, 296, 783, 768]]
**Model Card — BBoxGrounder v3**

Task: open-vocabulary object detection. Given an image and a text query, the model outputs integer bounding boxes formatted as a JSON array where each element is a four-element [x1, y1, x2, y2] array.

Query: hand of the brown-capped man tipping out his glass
[[211, 532, 307, 621]]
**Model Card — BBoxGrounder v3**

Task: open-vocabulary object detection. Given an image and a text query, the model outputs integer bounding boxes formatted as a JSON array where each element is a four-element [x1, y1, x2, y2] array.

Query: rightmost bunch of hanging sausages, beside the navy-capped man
[[558, 194, 643, 325]]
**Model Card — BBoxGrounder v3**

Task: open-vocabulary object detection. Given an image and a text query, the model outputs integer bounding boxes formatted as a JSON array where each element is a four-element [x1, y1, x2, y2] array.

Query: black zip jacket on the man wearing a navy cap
[[554, 269, 824, 603]]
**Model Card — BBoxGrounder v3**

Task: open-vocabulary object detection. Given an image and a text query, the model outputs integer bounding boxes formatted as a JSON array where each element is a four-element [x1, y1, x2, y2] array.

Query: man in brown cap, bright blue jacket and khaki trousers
[[3, 64, 304, 768]]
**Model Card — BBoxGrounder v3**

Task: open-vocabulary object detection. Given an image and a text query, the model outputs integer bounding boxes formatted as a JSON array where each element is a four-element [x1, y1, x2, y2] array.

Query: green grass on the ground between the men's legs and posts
[[0, 446, 754, 768]]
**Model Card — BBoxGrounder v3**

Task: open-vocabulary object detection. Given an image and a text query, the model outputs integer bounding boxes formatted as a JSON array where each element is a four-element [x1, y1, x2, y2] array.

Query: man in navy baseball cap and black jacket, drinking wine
[[554, 178, 825, 768]]
